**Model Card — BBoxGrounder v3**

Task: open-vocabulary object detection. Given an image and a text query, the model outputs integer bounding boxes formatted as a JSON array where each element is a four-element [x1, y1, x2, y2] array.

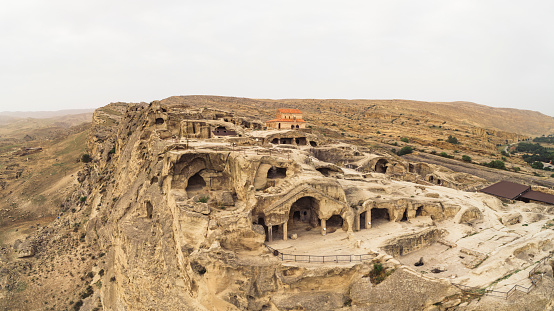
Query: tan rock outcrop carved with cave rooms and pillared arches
[[4, 98, 550, 310]]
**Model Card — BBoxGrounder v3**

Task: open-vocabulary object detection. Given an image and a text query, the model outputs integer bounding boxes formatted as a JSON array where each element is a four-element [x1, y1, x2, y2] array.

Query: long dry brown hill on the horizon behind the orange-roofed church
[[162, 96, 554, 137]]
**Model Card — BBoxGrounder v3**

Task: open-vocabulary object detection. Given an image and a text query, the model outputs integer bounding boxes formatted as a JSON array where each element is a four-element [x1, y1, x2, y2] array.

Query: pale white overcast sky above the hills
[[0, 0, 554, 116]]
